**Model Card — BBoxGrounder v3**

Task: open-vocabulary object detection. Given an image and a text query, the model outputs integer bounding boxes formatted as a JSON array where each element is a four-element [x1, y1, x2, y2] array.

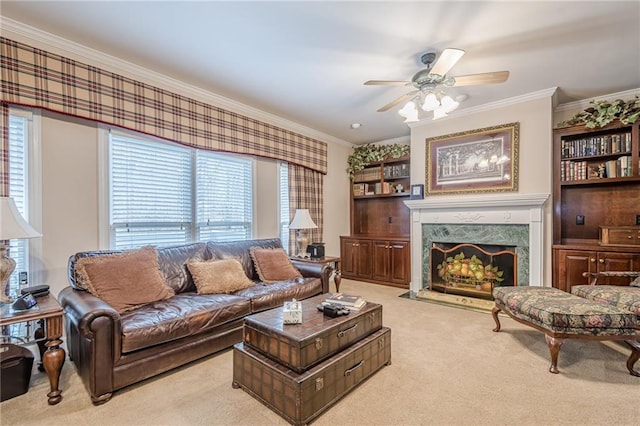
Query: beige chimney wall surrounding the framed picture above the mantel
[[411, 94, 553, 283]]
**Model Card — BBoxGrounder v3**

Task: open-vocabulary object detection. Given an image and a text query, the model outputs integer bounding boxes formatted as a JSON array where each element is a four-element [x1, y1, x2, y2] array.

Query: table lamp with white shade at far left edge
[[0, 197, 42, 303]]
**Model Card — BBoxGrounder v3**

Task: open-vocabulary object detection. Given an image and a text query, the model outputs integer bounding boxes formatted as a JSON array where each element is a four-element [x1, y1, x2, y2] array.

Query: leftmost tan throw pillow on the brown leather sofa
[[76, 247, 175, 313]]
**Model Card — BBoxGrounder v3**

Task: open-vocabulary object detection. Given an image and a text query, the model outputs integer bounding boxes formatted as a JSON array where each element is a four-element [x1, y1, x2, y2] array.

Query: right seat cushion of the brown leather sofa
[[233, 278, 322, 312]]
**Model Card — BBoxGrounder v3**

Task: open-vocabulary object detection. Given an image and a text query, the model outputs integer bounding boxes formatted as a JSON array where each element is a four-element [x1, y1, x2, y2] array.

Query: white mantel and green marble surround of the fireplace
[[405, 193, 549, 293]]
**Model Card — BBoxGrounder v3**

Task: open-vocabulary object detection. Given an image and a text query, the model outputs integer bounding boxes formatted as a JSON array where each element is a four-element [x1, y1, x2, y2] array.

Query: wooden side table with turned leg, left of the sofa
[[0, 294, 66, 405]]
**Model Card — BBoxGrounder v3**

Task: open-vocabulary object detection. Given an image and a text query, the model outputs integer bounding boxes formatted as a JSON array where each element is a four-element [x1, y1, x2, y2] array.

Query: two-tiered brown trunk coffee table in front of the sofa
[[233, 295, 391, 425]]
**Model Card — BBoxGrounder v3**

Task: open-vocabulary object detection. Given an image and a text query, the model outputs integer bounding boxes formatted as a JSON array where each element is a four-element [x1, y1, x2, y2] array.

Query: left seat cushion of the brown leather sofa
[[121, 292, 251, 353]]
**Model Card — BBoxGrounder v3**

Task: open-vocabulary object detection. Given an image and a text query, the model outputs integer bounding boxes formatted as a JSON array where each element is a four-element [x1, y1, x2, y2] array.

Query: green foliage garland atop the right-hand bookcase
[[559, 95, 640, 129]]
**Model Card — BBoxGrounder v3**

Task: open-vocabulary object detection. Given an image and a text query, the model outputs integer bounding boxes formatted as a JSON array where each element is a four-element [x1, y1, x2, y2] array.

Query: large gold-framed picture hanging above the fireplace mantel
[[424, 123, 520, 198]]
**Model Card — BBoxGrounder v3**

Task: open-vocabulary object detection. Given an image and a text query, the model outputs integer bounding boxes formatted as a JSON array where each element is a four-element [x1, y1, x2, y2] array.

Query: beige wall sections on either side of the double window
[[33, 112, 351, 294]]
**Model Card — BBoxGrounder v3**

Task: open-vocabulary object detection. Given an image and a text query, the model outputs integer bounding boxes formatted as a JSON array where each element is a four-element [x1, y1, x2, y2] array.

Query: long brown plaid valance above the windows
[[0, 37, 327, 174]]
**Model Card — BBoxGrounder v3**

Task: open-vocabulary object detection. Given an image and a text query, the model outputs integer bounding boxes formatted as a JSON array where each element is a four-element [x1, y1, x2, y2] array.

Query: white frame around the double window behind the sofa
[[98, 125, 257, 250]]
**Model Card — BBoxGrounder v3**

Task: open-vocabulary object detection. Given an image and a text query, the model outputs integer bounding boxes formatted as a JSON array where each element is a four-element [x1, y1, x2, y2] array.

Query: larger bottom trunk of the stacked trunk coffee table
[[233, 327, 391, 425]]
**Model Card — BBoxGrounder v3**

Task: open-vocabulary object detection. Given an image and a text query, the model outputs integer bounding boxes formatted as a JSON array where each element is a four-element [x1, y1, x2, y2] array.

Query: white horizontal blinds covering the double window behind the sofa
[[109, 132, 253, 249]]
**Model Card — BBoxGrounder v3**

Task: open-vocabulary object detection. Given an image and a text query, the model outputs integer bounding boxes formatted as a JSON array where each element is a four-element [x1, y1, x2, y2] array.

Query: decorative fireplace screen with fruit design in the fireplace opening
[[430, 243, 518, 299]]
